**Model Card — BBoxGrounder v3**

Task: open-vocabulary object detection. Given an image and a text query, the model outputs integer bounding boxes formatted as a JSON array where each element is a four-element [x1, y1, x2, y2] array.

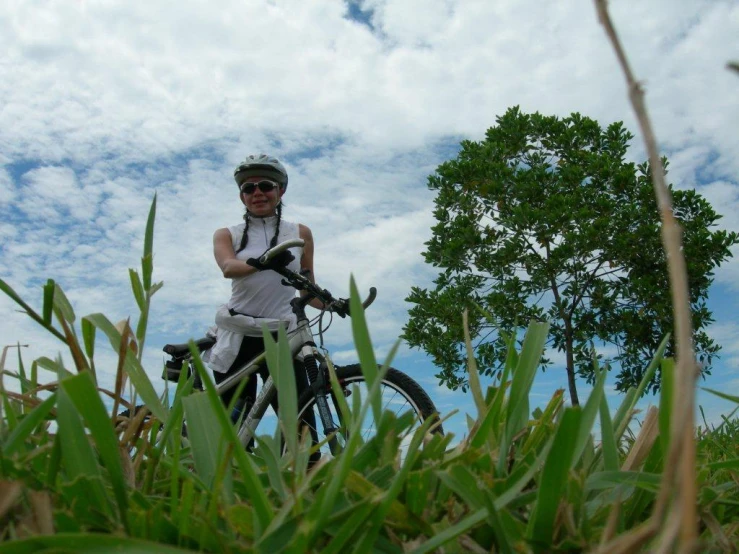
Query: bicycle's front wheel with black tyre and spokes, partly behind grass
[[298, 364, 444, 456]]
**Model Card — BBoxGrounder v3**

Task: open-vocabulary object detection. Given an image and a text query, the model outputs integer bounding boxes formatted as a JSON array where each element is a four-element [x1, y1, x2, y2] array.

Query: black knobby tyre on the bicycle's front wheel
[[298, 364, 444, 458]]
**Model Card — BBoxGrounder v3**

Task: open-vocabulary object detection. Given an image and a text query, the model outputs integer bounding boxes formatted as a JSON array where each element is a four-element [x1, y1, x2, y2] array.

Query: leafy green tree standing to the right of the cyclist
[[404, 107, 739, 404]]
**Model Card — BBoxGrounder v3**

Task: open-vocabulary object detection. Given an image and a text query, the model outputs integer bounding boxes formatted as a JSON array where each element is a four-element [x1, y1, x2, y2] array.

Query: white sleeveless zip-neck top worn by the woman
[[228, 216, 303, 321]]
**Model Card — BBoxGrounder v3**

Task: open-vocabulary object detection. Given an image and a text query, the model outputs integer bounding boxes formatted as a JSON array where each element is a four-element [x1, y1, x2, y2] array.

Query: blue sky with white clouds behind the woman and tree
[[0, 0, 739, 436]]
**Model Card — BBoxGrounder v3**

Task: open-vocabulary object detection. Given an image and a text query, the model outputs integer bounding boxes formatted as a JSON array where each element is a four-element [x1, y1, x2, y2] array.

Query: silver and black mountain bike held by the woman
[[162, 239, 443, 456]]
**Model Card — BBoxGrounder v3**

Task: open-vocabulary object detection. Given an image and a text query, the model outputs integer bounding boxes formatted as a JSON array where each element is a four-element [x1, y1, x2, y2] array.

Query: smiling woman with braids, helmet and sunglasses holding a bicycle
[[207, 154, 313, 417]]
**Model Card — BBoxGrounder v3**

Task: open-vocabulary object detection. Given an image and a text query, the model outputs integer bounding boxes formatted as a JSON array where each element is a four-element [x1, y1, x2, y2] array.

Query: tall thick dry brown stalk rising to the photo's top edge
[[595, 0, 698, 550]]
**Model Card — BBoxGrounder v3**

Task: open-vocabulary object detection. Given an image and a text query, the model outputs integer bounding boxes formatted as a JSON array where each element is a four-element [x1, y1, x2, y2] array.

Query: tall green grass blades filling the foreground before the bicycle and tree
[[0, 200, 739, 554]]
